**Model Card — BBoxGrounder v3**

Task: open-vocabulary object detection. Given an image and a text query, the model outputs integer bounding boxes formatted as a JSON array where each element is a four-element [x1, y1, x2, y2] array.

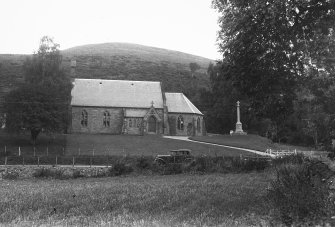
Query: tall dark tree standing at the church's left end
[[4, 36, 72, 144]]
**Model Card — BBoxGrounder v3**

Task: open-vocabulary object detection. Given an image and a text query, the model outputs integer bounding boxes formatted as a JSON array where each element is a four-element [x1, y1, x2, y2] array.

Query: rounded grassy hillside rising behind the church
[[0, 43, 212, 108]]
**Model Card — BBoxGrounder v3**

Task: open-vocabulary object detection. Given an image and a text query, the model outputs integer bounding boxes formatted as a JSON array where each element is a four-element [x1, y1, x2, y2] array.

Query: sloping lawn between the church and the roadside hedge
[[0, 133, 262, 156]]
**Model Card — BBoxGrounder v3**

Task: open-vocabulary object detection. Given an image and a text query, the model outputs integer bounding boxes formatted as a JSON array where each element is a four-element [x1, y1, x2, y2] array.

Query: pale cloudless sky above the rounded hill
[[0, 0, 221, 60]]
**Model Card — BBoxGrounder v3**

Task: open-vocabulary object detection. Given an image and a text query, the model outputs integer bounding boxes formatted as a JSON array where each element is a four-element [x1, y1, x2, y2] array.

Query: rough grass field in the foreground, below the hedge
[[0, 172, 271, 226]]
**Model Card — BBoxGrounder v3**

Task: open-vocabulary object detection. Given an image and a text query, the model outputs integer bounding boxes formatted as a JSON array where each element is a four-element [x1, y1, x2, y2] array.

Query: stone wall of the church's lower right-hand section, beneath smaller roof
[[169, 113, 204, 136]]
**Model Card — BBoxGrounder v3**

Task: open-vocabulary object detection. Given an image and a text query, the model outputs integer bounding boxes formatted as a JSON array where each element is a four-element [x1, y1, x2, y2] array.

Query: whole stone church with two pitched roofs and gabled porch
[[71, 79, 206, 136]]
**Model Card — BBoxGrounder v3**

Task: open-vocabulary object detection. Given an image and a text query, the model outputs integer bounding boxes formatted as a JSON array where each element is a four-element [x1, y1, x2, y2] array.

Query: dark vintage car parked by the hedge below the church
[[155, 149, 194, 165]]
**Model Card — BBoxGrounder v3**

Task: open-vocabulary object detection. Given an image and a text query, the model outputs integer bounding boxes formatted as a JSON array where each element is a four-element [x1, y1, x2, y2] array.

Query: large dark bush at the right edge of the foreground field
[[268, 161, 332, 225]]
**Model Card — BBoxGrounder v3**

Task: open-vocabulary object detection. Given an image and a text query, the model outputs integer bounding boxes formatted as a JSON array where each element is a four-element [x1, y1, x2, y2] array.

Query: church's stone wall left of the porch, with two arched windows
[[71, 107, 123, 134]]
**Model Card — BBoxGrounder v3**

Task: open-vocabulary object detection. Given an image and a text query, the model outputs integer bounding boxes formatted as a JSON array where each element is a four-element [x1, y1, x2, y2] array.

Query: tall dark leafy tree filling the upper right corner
[[212, 0, 335, 132]]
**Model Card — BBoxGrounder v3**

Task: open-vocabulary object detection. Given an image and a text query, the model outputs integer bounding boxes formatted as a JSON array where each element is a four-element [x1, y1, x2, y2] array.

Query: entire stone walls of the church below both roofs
[[71, 107, 206, 136]]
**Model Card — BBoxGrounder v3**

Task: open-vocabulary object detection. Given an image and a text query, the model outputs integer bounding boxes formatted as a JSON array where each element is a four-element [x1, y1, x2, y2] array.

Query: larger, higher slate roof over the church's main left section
[[71, 79, 163, 108]]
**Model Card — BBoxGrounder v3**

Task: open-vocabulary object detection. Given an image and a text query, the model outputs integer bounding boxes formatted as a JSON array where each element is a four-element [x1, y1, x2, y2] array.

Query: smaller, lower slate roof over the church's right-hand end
[[165, 93, 203, 115]]
